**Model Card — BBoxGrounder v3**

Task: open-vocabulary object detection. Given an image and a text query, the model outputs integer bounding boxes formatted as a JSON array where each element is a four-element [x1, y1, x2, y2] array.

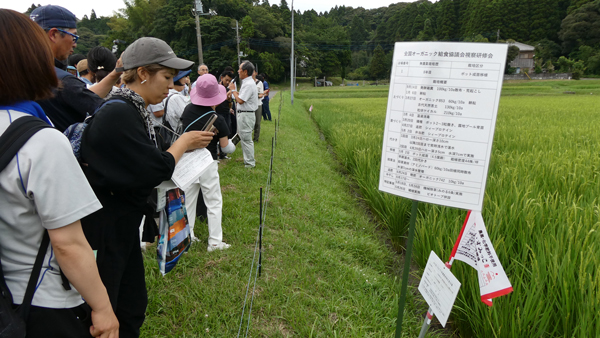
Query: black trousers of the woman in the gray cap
[[81, 191, 148, 338]]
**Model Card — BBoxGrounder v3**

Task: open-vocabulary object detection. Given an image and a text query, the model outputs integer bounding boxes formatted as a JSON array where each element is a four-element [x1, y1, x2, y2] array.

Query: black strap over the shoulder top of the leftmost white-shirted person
[[0, 116, 51, 171]]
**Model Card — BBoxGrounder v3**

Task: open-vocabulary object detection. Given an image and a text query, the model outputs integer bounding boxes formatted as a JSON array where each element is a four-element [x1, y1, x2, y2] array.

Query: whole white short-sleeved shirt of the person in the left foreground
[[0, 110, 102, 309]]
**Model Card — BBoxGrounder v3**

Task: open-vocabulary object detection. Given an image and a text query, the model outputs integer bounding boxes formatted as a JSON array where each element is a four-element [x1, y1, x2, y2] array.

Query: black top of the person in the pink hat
[[181, 104, 229, 160]]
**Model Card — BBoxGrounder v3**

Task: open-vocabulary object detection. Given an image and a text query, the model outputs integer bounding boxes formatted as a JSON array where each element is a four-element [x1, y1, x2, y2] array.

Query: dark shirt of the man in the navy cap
[[38, 60, 104, 132]]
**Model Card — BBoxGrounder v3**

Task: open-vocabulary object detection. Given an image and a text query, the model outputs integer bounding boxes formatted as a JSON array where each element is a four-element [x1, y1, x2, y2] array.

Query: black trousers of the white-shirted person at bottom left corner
[[26, 306, 92, 338]]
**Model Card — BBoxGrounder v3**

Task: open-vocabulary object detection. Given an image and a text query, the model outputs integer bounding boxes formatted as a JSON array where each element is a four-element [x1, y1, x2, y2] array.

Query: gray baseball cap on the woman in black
[[117, 37, 194, 71]]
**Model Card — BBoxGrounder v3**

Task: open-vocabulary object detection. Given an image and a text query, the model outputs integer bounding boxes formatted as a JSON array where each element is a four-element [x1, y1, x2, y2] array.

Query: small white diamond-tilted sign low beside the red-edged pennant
[[419, 251, 460, 327]]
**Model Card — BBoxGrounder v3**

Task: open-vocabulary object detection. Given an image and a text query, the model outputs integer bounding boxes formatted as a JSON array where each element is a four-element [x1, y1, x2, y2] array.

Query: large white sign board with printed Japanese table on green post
[[379, 42, 508, 211]]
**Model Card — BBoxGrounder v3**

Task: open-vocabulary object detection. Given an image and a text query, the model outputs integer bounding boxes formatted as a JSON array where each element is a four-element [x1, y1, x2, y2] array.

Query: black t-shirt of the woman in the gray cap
[[81, 96, 175, 208]]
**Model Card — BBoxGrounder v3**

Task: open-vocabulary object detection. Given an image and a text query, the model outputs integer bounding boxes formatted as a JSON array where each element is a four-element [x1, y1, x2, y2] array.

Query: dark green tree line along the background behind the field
[[29, 0, 600, 82]]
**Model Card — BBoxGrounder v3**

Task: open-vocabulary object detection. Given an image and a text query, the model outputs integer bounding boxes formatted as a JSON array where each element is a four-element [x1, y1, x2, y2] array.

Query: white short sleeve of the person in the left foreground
[[19, 129, 102, 229]]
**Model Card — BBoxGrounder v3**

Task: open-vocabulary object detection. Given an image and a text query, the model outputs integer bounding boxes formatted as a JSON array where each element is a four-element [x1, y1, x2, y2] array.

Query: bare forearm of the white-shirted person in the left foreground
[[48, 221, 119, 338]]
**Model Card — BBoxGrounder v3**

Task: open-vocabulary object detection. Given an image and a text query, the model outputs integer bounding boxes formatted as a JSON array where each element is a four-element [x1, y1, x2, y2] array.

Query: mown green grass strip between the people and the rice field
[[142, 93, 450, 337]]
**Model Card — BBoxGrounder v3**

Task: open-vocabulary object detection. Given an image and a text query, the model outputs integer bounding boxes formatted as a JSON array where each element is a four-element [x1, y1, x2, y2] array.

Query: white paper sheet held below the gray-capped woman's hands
[[171, 148, 214, 191]]
